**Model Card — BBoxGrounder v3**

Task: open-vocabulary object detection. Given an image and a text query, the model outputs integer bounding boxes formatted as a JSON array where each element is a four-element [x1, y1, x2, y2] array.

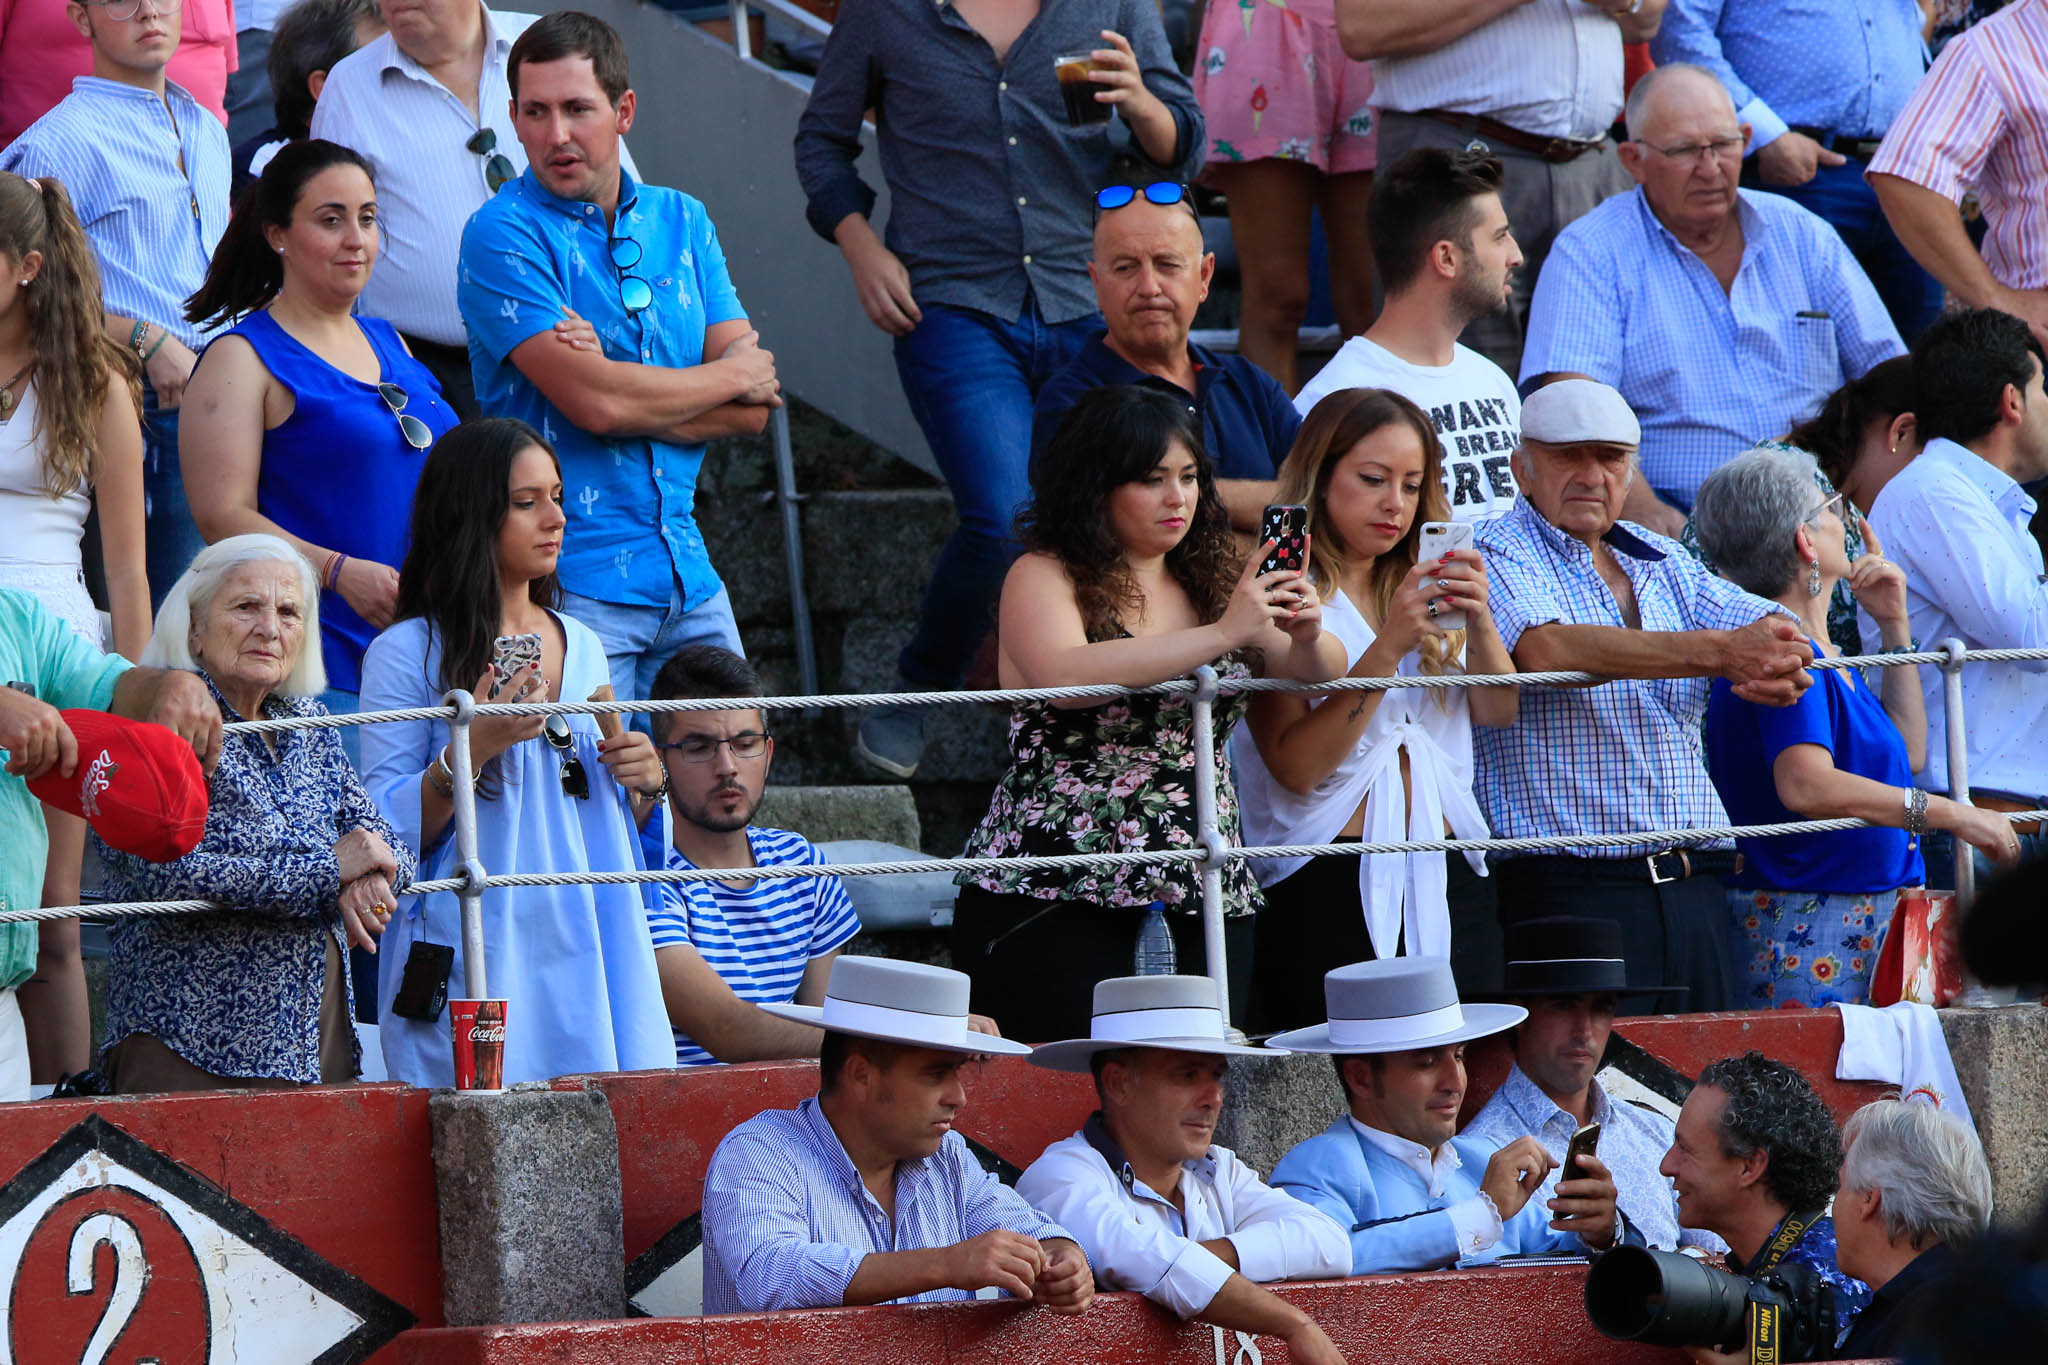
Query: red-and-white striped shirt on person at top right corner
[[1870, 0, 2048, 289]]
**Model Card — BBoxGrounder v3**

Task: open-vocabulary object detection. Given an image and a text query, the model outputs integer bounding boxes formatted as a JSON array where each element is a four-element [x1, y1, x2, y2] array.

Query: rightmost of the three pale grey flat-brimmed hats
[[1253, 958, 1530, 1060]]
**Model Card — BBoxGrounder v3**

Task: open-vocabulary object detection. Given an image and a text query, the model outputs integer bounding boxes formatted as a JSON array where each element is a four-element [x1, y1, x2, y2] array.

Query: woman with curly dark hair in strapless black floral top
[[952, 389, 1343, 1042]]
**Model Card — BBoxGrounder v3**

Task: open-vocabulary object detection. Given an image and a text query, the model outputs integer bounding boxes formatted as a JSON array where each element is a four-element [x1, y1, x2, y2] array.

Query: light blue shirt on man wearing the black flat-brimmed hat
[[1458, 1062, 1729, 1254]]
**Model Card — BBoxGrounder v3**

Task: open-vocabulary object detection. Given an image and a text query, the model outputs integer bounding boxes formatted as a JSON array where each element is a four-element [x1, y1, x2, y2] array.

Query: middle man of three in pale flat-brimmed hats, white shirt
[[1018, 976, 1352, 1365]]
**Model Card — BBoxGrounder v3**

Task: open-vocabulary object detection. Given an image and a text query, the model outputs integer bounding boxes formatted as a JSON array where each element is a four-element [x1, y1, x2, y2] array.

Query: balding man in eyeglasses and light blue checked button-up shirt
[[1522, 63, 1905, 536]]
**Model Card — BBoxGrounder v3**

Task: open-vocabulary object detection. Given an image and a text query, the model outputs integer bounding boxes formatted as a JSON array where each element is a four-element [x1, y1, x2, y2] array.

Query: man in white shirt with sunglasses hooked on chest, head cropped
[[311, 0, 633, 422]]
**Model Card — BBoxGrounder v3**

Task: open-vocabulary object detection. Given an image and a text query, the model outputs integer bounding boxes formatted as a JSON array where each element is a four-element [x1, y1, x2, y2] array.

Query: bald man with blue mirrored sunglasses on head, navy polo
[[1030, 184, 1300, 534]]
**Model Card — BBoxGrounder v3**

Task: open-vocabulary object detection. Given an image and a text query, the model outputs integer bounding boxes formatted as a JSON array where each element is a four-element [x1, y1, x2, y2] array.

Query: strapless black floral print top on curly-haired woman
[[958, 653, 1262, 917]]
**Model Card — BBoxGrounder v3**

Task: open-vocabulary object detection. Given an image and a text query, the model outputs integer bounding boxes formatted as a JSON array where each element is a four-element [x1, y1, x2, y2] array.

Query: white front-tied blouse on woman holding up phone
[[1231, 591, 1489, 958]]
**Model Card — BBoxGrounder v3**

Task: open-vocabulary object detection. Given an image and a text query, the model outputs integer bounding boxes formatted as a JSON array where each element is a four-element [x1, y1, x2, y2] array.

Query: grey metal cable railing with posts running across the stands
[[12, 641, 2048, 1031]]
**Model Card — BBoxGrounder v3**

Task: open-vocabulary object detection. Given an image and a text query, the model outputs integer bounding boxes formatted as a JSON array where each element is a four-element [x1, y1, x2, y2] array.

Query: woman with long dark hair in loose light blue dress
[[362, 417, 676, 1085]]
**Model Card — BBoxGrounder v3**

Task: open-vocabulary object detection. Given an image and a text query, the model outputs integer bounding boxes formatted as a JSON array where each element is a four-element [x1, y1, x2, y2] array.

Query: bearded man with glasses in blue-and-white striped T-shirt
[[641, 645, 860, 1066]]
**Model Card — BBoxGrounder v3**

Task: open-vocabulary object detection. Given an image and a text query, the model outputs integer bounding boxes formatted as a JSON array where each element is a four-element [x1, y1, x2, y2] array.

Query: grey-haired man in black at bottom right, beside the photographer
[[1835, 1099, 1991, 1361]]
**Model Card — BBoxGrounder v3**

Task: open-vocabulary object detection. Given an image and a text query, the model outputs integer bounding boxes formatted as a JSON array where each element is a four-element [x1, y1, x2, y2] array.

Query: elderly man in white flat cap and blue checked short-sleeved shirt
[[1475, 379, 1812, 1013]]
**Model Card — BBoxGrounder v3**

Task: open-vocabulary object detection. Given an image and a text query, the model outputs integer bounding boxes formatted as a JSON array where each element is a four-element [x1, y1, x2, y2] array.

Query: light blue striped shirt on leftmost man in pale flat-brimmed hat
[[705, 1097, 1073, 1314]]
